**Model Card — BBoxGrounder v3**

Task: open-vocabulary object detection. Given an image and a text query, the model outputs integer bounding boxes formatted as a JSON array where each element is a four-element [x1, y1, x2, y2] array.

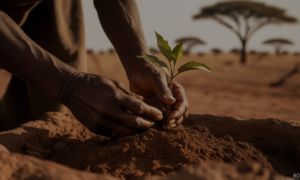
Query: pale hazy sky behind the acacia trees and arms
[[82, 0, 300, 52]]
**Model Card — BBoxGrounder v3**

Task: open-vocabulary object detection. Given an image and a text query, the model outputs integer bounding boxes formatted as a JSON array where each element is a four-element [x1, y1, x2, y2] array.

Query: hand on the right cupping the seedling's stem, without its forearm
[[128, 62, 188, 127]]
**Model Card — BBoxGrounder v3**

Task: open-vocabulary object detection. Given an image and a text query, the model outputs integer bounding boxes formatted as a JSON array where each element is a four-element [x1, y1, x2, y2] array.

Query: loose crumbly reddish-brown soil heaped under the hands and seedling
[[42, 125, 273, 180]]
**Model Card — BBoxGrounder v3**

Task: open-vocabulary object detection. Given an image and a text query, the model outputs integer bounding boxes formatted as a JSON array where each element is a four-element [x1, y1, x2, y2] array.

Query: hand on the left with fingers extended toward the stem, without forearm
[[61, 73, 163, 137]]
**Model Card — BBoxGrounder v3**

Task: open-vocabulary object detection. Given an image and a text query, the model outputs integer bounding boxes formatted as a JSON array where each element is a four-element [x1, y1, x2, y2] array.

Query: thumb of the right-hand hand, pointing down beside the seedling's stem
[[152, 78, 176, 104]]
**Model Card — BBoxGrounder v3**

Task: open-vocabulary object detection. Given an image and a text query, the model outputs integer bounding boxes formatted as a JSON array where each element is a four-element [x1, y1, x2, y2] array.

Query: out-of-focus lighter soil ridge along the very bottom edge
[[0, 152, 289, 180]]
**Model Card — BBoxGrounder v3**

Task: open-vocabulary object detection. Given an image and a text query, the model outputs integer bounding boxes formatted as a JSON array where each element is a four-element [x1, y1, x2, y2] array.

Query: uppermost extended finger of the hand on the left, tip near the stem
[[120, 94, 163, 121]]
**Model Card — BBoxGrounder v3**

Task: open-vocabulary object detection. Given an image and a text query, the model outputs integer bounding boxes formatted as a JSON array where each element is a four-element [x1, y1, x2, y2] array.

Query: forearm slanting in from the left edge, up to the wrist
[[0, 10, 76, 100]]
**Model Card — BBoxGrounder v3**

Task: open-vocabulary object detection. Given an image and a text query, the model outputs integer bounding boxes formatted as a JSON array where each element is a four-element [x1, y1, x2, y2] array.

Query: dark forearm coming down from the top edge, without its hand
[[94, 0, 148, 75]]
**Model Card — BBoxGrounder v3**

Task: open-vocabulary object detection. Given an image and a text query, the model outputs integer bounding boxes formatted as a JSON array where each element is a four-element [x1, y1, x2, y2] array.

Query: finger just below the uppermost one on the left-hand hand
[[111, 109, 154, 130]]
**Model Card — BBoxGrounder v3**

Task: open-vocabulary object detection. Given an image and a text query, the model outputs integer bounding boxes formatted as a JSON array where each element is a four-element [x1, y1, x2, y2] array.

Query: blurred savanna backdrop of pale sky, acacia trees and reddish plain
[[0, 0, 300, 120]]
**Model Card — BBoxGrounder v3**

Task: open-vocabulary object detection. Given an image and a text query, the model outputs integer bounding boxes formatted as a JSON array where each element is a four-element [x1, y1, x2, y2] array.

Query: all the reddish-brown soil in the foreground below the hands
[[0, 113, 300, 180]]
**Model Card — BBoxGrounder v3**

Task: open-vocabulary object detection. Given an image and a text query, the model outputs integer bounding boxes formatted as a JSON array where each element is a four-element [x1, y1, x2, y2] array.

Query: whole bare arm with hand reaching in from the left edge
[[0, 11, 162, 136]]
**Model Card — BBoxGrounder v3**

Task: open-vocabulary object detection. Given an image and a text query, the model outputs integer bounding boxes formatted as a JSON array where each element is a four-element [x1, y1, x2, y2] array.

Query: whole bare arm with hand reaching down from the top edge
[[94, 0, 188, 124]]
